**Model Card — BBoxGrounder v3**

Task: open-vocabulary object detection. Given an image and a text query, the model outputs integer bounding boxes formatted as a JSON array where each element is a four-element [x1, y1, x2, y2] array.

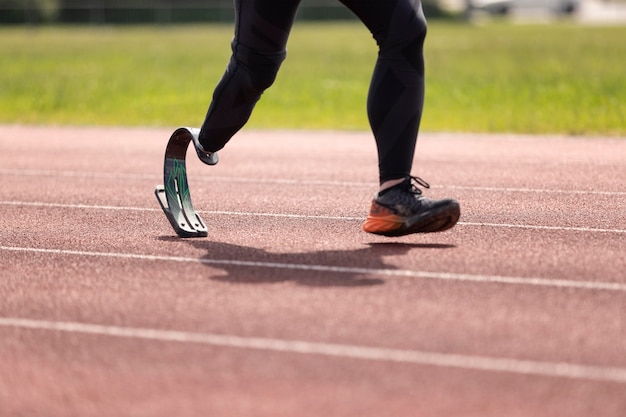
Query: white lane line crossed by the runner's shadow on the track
[[0, 246, 626, 292]]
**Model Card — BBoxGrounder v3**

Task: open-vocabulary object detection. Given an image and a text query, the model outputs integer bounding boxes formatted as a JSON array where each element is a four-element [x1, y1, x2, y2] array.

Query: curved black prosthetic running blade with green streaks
[[154, 127, 208, 237]]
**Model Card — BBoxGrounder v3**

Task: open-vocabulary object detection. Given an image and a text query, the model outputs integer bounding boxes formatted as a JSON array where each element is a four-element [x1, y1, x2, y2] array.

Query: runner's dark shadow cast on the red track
[[171, 240, 455, 287]]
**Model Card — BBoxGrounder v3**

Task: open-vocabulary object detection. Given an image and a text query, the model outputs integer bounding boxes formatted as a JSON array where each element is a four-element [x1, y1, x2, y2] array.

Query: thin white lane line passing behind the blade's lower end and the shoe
[[0, 201, 626, 234]]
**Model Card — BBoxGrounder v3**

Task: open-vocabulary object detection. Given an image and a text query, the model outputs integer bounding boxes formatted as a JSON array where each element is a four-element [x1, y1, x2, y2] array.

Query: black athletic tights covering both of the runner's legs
[[200, 0, 426, 183]]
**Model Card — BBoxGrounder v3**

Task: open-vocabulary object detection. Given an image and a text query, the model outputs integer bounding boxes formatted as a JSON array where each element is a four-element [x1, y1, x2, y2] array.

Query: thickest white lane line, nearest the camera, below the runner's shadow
[[0, 317, 626, 383]]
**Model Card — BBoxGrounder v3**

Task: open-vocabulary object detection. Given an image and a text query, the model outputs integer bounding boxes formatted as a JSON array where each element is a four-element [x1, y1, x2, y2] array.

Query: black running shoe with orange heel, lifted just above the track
[[363, 177, 461, 236]]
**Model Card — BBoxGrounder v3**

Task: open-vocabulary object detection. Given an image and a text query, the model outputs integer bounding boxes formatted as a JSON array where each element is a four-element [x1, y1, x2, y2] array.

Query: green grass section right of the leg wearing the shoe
[[424, 25, 626, 135]]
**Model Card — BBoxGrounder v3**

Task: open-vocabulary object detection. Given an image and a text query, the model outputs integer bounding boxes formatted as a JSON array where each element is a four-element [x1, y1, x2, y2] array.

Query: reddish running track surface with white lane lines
[[0, 126, 626, 417]]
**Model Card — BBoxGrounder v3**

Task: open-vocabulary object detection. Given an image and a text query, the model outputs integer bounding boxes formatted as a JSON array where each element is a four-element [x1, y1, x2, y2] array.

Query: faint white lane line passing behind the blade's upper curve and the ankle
[[0, 169, 626, 196]]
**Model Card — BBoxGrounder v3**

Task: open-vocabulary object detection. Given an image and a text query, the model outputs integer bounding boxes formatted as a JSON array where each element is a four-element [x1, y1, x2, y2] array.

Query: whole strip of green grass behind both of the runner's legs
[[0, 22, 626, 136]]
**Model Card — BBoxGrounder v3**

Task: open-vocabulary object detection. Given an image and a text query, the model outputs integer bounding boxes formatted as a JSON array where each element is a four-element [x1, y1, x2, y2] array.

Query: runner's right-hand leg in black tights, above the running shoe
[[340, 0, 426, 184]]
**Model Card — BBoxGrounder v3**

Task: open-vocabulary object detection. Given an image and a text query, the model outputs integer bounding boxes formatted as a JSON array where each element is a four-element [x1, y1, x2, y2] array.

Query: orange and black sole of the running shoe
[[363, 200, 461, 237]]
